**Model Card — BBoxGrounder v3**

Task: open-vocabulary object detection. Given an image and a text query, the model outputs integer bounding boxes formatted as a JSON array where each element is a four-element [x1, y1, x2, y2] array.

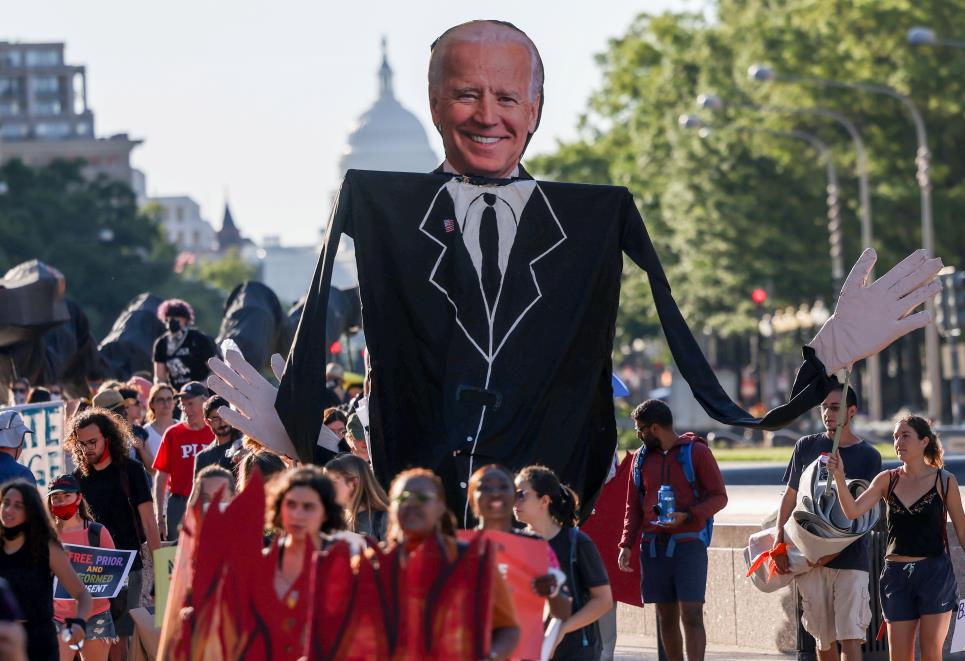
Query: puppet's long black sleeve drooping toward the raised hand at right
[[622, 191, 837, 429]]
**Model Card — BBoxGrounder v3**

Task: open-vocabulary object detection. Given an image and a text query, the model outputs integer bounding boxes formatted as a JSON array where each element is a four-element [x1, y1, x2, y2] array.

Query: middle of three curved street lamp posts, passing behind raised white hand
[[697, 94, 884, 420]]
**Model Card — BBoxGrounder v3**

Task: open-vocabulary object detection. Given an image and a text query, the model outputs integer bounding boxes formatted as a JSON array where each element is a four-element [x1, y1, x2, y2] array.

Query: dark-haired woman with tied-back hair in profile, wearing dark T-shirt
[[513, 466, 613, 661]]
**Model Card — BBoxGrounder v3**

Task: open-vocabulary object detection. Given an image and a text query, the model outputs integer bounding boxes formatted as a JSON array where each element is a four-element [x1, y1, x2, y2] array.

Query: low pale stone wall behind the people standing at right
[[617, 523, 965, 652]]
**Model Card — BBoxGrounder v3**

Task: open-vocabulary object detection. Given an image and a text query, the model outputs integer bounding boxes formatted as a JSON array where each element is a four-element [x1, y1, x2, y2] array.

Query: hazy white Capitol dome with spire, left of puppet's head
[[339, 37, 441, 176]]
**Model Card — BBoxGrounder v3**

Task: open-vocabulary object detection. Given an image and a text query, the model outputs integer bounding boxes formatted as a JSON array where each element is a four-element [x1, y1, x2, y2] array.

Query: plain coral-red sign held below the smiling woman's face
[[458, 530, 551, 659]]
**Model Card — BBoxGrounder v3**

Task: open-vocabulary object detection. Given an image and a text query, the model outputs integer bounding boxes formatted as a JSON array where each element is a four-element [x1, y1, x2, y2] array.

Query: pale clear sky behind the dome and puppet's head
[[0, 0, 706, 244]]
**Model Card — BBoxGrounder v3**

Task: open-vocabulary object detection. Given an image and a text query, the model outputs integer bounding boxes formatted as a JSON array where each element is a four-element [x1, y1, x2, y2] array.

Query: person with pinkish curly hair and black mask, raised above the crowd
[[154, 298, 218, 390]]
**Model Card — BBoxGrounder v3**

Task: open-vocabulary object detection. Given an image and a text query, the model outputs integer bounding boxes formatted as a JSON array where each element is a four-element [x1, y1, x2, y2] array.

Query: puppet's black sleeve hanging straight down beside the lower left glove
[[275, 170, 353, 463]]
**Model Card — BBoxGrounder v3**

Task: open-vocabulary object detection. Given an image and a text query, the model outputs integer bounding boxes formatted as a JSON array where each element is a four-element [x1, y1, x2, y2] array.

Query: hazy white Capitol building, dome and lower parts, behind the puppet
[[261, 37, 434, 303]]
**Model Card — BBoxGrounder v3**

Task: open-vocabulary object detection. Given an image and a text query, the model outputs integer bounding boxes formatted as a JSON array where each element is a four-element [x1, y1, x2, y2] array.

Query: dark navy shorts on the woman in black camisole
[[878, 553, 958, 622]]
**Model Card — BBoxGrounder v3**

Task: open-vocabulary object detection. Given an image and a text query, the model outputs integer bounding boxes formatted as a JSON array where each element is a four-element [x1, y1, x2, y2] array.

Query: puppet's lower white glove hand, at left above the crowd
[[208, 349, 298, 459]]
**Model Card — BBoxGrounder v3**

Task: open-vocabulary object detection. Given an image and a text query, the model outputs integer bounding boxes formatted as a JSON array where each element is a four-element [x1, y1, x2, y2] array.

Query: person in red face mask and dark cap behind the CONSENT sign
[[47, 475, 117, 661]]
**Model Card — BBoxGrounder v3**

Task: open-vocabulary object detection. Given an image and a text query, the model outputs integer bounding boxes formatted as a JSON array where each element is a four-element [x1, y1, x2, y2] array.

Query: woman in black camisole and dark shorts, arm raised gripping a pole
[[828, 416, 965, 661]]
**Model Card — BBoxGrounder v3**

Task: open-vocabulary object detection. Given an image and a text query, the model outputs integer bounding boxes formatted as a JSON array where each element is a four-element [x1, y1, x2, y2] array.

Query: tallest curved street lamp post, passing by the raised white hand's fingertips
[[747, 64, 942, 420]]
